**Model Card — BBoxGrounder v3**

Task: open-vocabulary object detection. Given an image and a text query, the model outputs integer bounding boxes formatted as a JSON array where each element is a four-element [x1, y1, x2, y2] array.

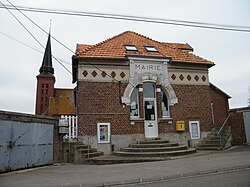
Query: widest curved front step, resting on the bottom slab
[[113, 148, 196, 157]]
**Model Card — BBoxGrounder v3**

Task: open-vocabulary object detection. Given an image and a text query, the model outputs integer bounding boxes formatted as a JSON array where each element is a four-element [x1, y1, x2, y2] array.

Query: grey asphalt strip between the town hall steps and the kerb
[[0, 146, 250, 187]]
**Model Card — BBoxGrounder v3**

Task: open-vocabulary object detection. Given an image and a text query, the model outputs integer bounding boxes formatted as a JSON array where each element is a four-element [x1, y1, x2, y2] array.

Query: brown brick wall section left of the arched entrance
[[78, 81, 144, 135]]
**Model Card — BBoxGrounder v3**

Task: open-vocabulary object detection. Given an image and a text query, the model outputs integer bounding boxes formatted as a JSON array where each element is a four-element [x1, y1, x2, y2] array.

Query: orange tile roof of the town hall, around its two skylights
[[76, 31, 214, 66]]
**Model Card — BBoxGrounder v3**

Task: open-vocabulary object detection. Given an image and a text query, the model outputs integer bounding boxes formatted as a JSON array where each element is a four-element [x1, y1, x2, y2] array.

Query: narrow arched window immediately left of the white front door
[[130, 87, 139, 118]]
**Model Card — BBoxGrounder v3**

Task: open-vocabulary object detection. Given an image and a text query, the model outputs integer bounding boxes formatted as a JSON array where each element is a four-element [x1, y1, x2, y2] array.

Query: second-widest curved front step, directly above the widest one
[[121, 145, 187, 152]]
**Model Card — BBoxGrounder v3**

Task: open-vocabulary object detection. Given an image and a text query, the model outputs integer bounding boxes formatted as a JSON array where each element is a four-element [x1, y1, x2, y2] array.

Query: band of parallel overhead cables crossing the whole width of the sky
[[0, 3, 250, 32]]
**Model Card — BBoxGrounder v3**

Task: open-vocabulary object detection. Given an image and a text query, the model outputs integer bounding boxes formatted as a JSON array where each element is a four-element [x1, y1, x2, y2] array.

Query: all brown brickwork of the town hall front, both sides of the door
[[78, 81, 216, 135]]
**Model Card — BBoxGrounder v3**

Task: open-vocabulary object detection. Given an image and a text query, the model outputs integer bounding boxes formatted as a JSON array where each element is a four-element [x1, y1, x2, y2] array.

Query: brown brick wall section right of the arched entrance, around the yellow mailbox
[[159, 85, 212, 133]]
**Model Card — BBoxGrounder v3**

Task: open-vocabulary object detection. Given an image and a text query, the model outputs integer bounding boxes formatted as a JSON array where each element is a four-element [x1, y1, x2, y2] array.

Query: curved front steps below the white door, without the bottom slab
[[113, 140, 196, 157]]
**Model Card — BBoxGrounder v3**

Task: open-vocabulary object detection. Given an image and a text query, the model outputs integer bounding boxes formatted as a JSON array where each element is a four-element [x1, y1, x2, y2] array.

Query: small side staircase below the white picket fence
[[63, 141, 104, 164]]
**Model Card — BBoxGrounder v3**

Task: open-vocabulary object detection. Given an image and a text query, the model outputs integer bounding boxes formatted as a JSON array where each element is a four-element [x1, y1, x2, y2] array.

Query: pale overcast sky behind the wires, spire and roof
[[0, 0, 250, 113]]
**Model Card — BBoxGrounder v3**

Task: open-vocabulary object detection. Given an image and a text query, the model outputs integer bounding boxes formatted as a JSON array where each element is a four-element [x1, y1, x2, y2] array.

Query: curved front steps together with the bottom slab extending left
[[88, 140, 196, 165]]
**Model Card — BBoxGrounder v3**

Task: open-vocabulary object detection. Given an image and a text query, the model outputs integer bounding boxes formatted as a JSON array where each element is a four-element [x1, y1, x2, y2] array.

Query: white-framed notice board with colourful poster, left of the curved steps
[[97, 123, 110, 143]]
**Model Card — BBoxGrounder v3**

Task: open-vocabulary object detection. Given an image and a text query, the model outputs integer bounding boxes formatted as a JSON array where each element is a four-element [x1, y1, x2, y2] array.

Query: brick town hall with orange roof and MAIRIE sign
[[72, 31, 230, 154]]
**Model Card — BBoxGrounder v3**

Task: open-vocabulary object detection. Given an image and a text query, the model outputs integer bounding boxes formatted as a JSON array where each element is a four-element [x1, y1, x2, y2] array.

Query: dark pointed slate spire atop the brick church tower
[[39, 33, 54, 75]]
